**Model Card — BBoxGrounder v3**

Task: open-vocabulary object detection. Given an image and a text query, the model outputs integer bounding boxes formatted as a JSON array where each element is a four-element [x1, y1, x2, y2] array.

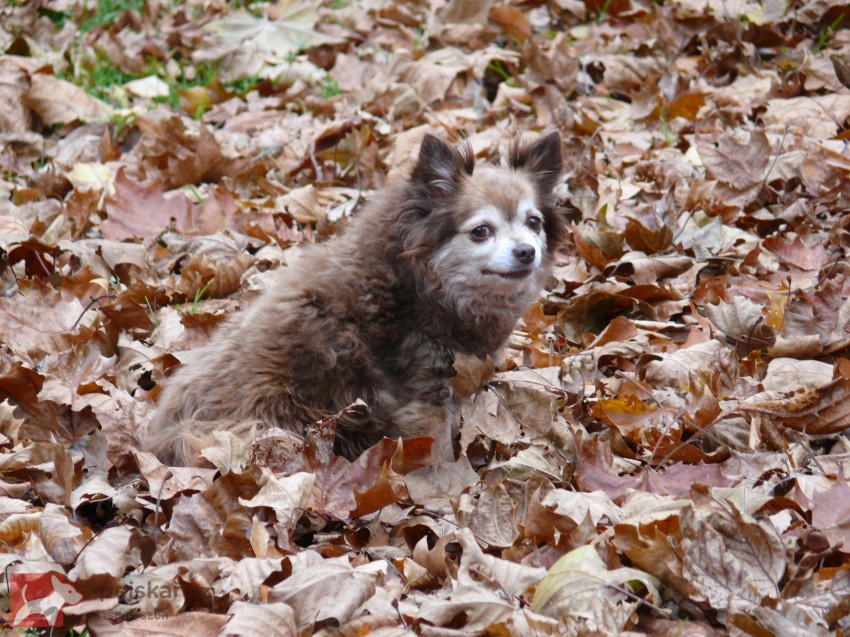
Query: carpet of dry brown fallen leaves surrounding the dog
[[0, 0, 850, 636]]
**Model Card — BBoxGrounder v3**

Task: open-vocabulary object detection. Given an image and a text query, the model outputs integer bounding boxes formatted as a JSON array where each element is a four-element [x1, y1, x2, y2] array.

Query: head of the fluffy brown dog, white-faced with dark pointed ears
[[405, 133, 565, 304]]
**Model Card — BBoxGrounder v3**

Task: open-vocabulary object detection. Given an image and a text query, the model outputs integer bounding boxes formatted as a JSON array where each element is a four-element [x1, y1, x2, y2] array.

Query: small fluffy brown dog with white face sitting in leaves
[[145, 133, 566, 464]]
